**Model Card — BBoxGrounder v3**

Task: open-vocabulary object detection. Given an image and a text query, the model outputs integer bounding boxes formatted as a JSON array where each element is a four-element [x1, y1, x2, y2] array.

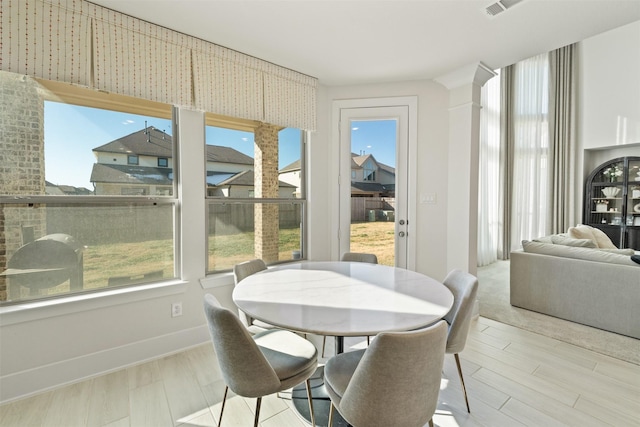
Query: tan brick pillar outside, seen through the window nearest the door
[[253, 123, 280, 263]]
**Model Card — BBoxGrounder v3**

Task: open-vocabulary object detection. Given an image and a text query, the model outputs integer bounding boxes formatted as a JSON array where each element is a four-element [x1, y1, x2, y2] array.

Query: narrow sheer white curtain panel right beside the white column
[[478, 72, 502, 267]]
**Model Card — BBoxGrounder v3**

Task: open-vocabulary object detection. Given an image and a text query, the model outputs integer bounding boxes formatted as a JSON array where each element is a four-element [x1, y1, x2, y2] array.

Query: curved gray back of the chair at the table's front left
[[204, 294, 280, 397]]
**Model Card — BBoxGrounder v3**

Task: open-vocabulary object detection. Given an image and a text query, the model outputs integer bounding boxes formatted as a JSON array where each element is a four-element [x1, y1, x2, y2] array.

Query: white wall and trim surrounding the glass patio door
[[308, 80, 449, 279]]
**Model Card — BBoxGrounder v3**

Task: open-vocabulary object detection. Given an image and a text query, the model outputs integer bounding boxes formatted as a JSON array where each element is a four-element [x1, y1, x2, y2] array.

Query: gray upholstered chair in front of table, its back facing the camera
[[324, 320, 447, 427]]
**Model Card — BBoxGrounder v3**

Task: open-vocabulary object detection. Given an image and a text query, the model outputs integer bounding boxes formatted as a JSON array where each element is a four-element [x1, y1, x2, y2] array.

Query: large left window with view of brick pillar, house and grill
[[0, 72, 177, 305]]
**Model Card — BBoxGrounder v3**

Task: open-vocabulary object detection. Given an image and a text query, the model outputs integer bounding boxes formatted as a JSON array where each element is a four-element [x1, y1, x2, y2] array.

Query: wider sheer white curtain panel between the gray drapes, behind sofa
[[511, 53, 550, 249]]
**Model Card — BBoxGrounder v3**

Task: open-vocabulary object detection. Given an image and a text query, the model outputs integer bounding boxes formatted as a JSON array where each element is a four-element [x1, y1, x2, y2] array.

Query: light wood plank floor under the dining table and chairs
[[0, 317, 640, 427]]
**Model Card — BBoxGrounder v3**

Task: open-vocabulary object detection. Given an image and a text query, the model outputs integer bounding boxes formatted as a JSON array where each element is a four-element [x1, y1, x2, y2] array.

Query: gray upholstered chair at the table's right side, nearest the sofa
[[443, 270, 478, 412]]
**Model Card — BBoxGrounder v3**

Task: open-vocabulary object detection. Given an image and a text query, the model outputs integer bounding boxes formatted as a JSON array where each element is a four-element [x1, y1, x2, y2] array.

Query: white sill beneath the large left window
[[0, 280, 187, 326]]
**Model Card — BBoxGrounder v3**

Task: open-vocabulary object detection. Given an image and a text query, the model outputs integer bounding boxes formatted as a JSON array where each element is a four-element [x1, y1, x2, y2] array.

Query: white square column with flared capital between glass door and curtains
[[436, 63, 496, 274]]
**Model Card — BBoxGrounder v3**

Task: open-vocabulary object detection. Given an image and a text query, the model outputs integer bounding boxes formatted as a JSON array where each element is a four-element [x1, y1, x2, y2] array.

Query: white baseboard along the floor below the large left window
[[0, 325, 211, 404]]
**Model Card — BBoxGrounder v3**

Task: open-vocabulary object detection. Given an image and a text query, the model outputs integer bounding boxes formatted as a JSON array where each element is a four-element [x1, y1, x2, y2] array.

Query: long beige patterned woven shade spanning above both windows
[[0, 0, 317, 130]]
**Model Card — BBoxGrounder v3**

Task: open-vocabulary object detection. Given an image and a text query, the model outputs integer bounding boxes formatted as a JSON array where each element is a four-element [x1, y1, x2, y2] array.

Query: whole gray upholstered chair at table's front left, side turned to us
[[204, 294, 318, 427]]
